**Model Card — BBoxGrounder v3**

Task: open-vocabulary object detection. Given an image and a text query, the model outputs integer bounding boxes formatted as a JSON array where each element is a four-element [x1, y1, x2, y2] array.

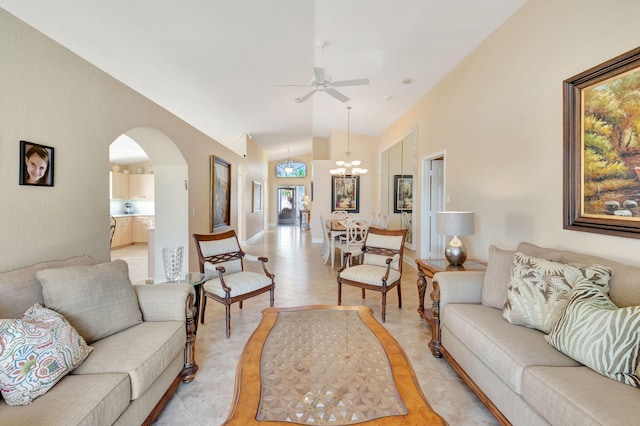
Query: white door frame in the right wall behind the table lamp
[[420, 149, 447, 259]]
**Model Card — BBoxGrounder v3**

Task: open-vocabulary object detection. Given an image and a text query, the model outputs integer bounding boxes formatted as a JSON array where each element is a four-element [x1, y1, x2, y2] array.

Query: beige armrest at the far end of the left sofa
[[133, 284, 196, 321]]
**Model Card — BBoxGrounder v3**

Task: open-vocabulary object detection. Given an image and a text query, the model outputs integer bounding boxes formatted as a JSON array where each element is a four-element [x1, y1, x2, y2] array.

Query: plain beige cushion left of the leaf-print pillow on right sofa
[[482, 245, 515, 309]]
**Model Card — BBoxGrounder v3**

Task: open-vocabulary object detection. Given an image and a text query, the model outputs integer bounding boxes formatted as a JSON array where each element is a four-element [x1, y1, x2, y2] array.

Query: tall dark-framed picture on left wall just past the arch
[[209, 155, 231, 232]]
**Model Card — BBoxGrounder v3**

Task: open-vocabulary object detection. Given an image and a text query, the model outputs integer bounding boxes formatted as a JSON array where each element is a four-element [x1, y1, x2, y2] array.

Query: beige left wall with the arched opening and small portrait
[[0, 9, 260, 271]]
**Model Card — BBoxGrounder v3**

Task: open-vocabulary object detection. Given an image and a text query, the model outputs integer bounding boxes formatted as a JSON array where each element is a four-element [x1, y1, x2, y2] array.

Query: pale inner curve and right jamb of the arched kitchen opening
[[110, 127, 189, 280]]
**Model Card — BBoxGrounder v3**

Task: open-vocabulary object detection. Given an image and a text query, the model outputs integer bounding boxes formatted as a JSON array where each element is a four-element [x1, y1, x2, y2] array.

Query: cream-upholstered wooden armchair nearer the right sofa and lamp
[[337, 227, 407, 323]]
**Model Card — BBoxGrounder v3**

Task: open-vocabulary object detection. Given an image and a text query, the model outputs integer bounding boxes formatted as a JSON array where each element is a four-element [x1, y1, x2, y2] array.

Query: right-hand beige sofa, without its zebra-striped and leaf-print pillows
[[429, 243, 640, 425]]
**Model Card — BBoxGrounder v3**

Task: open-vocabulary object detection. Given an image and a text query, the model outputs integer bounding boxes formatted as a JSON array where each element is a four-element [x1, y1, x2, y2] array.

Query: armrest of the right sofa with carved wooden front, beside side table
[[429, 271, 485, 358]]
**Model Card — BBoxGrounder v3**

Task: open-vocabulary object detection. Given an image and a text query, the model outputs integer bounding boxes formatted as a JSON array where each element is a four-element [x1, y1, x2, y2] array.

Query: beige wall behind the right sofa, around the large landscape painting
[[379, 0, 640, 264]]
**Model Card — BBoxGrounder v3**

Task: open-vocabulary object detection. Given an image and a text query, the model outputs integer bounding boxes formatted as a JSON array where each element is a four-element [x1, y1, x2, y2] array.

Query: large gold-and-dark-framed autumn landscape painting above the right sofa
[[563, 48, 640, 238]]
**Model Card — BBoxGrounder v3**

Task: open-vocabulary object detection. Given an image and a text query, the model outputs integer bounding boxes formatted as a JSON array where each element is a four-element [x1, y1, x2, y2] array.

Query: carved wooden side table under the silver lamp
[[416, 259, 487, 358]]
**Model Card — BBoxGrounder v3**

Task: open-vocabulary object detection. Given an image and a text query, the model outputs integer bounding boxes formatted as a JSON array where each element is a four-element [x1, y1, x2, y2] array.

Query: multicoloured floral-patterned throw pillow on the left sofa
[[0, 304, 93, 405]]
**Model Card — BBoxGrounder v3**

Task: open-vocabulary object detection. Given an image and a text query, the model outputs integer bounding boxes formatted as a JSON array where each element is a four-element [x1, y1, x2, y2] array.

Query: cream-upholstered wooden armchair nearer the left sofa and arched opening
[[193, 230, 275, 339]]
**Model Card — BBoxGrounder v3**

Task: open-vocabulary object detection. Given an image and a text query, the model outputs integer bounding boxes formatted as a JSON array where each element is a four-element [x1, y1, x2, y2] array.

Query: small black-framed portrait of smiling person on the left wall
[[19, 141, 54, 186]]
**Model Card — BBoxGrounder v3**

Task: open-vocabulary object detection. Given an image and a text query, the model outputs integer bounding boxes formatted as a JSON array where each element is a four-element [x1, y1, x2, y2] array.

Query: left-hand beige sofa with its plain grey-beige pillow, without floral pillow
[[0, 256, 198, 425]]
